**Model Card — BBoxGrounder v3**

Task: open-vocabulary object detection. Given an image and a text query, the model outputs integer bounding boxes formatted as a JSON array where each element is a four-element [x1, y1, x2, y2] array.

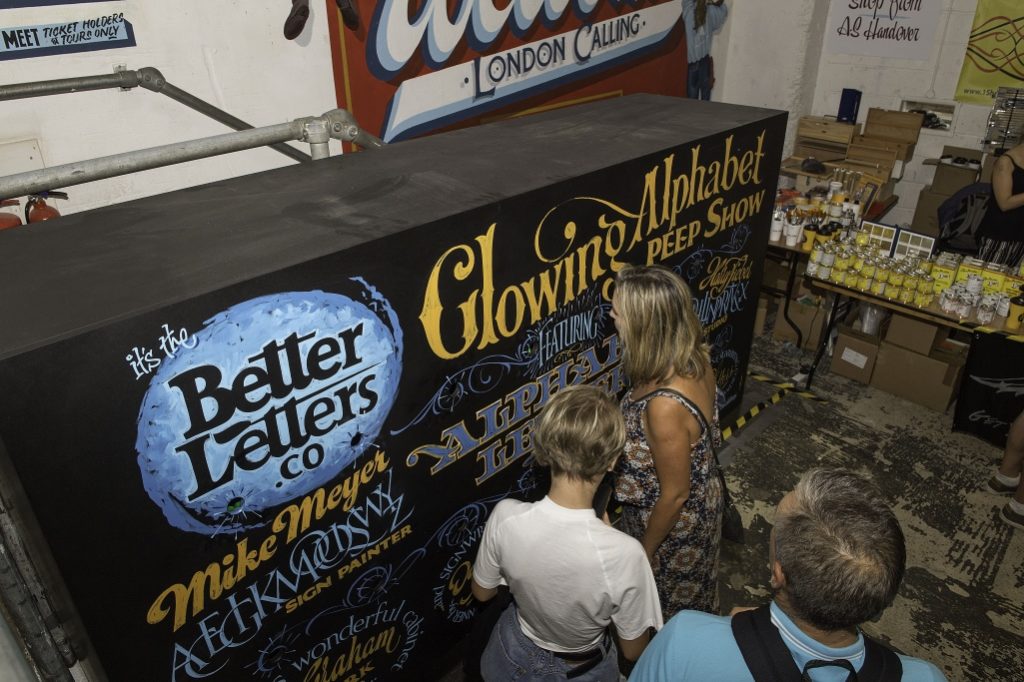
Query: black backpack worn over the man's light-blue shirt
[[732, 606, 903, 682]]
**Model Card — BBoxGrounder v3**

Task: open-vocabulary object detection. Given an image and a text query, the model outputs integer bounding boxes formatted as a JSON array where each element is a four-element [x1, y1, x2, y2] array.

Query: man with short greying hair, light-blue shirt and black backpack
[[630, 469, 945, 682]]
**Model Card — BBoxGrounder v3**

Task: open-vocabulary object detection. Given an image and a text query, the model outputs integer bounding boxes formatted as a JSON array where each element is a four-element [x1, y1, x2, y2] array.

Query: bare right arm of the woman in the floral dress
[[640, 397, 699, 559]]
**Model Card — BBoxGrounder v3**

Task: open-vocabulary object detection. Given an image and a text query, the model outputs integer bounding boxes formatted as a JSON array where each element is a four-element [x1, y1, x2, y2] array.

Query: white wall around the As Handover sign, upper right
[[716, 0, 990, 224]]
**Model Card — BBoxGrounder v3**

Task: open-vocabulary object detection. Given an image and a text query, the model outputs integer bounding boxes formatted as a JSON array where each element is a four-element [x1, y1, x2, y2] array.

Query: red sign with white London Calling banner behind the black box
[[329, 0, 686, 141]]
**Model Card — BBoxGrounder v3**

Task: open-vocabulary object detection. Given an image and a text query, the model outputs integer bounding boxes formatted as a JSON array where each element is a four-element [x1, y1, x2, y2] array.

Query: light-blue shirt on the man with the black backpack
[[630, 601, 946, 682]]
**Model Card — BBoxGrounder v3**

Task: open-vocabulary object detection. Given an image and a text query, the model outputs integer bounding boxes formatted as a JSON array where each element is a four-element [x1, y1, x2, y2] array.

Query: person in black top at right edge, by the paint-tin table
[[978, 144, 1024, 268]]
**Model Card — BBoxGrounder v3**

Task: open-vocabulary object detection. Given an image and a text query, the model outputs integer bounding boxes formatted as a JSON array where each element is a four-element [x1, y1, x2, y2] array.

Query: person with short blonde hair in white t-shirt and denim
[[473, 386, 663, 682]]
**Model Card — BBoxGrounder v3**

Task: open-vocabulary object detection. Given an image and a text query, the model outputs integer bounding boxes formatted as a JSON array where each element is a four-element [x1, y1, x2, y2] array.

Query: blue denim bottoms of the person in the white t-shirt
[[480, 604, 620, 682]]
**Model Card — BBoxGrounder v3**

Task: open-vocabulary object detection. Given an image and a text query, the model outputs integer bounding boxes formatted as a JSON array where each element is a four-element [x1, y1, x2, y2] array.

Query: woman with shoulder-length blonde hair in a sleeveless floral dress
[[611, 265, 723, 620]]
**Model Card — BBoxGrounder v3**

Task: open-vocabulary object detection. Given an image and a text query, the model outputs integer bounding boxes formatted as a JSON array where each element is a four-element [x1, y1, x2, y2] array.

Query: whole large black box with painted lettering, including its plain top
[[0, 95, 785, 681]]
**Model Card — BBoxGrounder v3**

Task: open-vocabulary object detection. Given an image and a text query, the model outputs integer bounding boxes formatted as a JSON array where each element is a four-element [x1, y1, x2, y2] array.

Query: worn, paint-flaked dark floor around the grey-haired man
[[443, 327, 1024, 682]]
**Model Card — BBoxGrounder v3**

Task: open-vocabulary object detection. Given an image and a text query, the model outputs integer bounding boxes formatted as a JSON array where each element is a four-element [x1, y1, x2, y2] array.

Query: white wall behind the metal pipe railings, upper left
[[0, 0, 340, 213]]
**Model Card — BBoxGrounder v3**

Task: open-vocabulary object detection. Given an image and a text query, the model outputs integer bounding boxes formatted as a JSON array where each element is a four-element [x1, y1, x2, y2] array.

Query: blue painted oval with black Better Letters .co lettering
[[135, 280, 401, 535]]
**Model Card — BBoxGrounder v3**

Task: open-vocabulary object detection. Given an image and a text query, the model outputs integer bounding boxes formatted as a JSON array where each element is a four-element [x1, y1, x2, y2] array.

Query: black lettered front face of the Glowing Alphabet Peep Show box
[[0, 98, 784, 682]]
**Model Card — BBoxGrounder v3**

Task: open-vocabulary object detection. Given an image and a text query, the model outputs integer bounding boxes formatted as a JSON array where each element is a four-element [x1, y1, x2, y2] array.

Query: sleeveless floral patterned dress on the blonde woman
[[615, 389, 723, 621]]
